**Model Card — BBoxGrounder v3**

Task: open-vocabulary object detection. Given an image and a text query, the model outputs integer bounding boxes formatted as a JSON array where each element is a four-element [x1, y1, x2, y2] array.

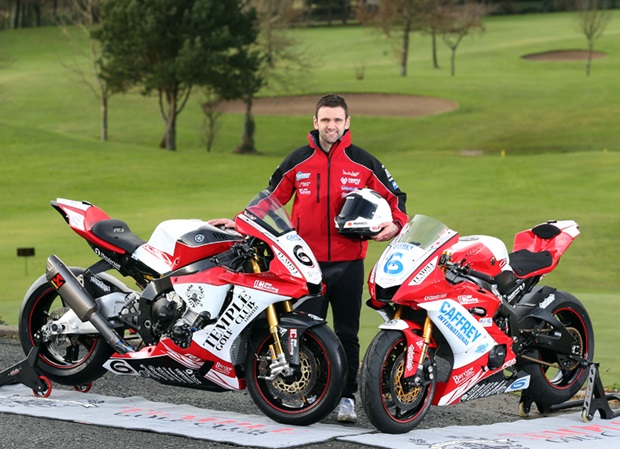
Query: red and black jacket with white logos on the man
[[267, 130, 408, 262]]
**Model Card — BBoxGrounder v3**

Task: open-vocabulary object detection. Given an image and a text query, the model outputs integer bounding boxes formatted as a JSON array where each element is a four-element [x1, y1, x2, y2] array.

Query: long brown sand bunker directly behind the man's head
[[218, 94, 459, 117]]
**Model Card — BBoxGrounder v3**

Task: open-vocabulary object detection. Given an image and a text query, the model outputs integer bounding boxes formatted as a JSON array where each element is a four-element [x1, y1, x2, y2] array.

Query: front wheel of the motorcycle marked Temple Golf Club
[[246, 325, 347, 426]]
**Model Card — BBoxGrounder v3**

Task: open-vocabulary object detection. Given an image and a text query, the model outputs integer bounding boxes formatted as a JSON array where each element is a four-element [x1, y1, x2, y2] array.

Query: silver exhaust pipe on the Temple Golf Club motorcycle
[[45, 254, 135, 354]]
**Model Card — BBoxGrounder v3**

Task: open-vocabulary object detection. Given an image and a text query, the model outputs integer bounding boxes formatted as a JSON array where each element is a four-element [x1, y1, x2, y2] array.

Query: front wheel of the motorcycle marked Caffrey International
[[361, 331, 437, 434]]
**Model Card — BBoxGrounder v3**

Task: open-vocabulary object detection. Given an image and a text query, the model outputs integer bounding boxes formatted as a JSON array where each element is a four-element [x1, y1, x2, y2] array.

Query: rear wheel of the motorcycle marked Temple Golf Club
[[18, 268, 114, 386]]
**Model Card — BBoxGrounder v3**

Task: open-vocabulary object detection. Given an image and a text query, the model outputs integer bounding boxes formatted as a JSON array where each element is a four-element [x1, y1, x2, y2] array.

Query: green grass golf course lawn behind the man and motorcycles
[[0, 11, 620, 385]]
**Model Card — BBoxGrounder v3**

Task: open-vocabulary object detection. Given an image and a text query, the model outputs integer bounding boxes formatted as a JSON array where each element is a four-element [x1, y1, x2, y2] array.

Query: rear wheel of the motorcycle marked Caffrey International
[[521, 291, 594, 413]]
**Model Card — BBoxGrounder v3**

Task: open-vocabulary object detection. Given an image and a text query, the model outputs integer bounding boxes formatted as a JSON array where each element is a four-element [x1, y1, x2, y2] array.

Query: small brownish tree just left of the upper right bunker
[[441, 2, 488, 76]]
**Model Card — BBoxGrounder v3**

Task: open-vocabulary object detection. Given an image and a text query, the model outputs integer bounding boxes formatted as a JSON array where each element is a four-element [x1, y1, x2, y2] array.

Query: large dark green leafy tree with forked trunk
[[94, 0, 257, 150]]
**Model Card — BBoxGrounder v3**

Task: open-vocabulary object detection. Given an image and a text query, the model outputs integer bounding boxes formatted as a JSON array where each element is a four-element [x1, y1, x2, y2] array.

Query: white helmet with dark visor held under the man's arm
[[334, 188, 392, 237]]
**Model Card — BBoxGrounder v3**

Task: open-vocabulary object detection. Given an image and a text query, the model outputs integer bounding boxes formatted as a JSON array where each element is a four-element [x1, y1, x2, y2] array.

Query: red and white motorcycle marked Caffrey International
[[360, 215, 594, 433]]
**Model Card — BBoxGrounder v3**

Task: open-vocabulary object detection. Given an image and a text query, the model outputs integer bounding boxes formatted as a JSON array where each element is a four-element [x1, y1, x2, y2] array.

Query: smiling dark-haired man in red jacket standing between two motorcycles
[[267, 94, 408, 422]]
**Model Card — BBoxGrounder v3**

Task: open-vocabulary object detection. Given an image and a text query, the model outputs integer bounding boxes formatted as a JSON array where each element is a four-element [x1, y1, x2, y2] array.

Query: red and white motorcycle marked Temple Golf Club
[[19, 194, 346, 425]]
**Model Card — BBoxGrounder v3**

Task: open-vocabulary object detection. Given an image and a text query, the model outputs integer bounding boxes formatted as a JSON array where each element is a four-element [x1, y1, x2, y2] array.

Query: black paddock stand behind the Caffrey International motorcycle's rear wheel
[[519, 362, 620, 422]]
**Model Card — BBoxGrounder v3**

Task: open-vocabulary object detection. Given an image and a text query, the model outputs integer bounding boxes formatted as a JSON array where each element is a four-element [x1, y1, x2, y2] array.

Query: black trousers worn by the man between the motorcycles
[[299, 259, 364, 398]]
